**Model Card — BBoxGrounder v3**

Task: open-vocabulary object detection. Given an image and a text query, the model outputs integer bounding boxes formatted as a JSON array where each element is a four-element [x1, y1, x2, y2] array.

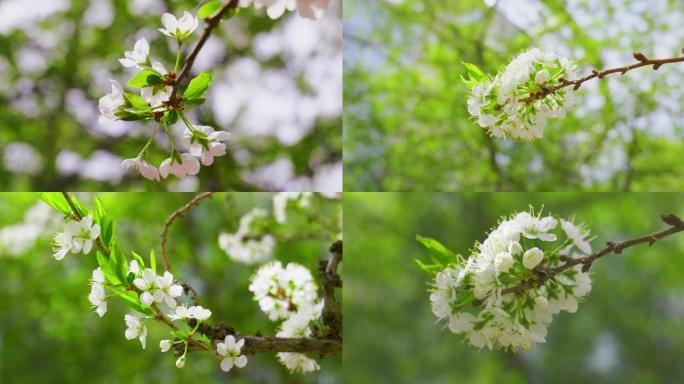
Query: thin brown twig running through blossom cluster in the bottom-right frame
[[501, 213, 684, 295]]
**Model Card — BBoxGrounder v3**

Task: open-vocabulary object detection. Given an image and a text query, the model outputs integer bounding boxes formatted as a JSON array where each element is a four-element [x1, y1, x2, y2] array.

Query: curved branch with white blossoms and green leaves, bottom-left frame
[[43, 193, 342, 373]]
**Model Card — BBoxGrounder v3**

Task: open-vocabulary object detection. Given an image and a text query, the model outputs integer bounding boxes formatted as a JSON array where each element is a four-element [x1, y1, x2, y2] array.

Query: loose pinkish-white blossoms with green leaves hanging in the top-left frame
[[99, 12, 230, 181]]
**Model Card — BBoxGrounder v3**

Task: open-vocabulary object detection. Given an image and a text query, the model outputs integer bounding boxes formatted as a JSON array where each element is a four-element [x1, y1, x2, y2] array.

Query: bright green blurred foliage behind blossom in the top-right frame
[[344, 0, 684, 192]]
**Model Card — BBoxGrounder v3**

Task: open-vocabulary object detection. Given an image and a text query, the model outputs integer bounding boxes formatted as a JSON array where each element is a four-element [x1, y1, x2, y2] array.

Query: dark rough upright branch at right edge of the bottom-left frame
[[319, 240, 342, 341]]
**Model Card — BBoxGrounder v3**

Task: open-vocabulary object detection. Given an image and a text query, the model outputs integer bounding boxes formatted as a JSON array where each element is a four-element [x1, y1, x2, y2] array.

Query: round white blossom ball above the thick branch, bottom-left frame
[[249, 261, 318, 321]]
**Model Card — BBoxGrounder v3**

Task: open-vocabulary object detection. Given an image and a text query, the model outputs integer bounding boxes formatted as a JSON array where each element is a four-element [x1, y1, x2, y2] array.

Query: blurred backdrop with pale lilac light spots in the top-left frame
[[0, 0, 342, 191]]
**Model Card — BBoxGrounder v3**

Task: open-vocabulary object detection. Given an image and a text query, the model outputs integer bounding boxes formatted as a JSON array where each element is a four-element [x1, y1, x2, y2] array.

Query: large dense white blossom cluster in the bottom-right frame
[[430, 211, 591, 350]]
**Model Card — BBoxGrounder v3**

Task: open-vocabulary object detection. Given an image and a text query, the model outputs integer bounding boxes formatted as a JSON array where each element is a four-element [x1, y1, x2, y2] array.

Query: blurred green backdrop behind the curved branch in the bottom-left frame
[[0, 193, 342, 384]]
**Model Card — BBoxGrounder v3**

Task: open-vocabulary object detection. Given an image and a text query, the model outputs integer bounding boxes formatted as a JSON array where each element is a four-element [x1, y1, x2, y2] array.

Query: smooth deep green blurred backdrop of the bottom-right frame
[[344, 193, 684, 384]]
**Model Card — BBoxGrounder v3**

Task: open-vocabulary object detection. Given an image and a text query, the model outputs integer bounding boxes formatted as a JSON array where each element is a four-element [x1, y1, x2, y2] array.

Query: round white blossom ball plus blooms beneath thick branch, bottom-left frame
[[249, 261, 323, 373]]
